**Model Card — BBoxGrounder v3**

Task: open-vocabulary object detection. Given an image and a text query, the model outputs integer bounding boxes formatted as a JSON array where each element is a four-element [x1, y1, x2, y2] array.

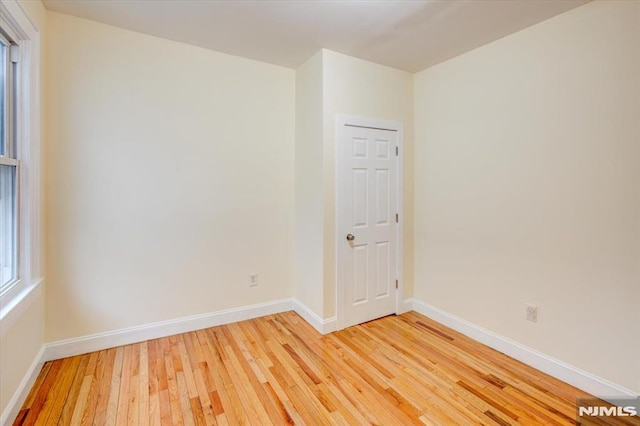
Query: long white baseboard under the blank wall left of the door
[[44, 299, 293, 361]]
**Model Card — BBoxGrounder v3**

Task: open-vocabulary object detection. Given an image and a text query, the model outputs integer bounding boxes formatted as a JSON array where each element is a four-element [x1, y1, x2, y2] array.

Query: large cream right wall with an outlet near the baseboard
[[414, 1, 640, 392]]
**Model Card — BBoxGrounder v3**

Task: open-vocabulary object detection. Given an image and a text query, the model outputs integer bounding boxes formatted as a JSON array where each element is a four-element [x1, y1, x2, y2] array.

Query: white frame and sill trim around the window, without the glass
[[0, 0, 42, 336]]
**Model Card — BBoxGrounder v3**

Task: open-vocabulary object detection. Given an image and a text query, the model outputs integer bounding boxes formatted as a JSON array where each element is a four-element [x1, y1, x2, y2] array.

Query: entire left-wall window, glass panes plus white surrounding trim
[[0, 0, 43, 318]]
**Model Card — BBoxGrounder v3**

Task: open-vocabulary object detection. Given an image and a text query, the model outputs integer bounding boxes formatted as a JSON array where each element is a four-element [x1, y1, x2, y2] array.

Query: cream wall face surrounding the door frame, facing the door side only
[[322, 50, 413, 318]]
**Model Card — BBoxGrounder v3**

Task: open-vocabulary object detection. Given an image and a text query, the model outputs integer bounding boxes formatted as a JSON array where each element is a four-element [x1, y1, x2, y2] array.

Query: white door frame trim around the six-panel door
[[335, 114, 404, 330]]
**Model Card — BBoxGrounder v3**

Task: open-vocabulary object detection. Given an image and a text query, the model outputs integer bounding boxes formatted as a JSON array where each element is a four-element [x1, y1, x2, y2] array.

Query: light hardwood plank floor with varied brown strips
[[14, 312, 640, 425]]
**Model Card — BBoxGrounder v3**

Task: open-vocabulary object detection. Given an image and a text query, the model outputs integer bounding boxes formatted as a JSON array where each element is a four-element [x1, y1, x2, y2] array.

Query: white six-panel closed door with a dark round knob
[[337, 121, 398, 327]]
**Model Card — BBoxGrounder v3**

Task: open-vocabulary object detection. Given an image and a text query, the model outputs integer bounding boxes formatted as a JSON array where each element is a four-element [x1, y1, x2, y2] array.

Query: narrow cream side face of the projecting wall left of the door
[[294, 51, 324, 318]]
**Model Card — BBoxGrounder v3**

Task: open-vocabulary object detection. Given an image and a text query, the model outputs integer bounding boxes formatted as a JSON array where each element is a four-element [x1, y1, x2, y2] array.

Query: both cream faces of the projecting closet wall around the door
[[294, 49, 413, 319]]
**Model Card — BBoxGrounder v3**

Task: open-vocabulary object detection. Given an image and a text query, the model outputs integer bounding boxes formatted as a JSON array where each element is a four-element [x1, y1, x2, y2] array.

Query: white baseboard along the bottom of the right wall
[[412, 299, 638, 403]]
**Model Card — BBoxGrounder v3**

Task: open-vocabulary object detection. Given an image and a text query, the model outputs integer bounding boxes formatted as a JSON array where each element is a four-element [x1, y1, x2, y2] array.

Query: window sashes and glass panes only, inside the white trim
[[0, 31, 20, 294]]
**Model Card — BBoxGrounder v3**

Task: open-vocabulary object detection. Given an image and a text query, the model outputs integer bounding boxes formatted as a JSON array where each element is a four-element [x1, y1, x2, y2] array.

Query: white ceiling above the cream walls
[[43, 0, 587, 72]]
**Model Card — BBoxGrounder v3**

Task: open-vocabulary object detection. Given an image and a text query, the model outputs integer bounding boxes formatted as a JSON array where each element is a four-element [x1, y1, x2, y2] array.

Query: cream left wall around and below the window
[[0, 0, 47, 420]]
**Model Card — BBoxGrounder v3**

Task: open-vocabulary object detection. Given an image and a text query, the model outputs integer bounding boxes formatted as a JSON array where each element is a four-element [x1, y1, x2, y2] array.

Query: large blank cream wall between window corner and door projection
[[46, 12, 295, 341]]
